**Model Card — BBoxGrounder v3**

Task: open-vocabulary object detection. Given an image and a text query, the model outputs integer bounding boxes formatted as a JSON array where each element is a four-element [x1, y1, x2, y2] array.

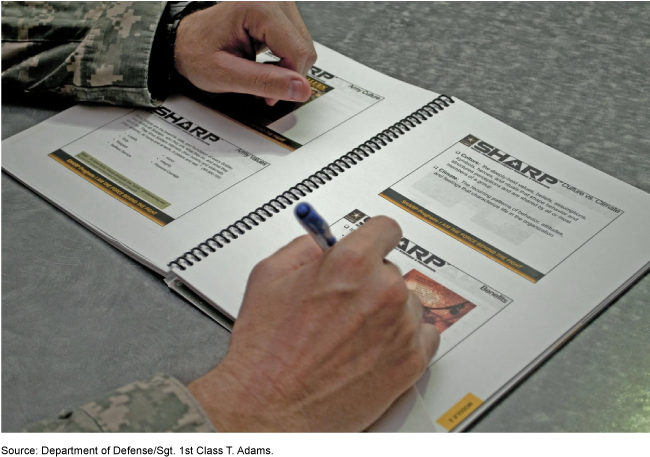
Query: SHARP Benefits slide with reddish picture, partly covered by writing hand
[[330, 210, 512, 363]]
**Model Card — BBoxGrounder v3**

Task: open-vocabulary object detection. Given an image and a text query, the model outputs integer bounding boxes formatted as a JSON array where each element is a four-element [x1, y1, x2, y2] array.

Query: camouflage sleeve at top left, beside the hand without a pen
[[2, 1, 165, 107]]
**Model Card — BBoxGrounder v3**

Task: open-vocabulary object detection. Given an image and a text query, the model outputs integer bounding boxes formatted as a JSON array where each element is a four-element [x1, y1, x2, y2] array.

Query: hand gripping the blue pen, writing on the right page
[[189, 217, 439, 432]]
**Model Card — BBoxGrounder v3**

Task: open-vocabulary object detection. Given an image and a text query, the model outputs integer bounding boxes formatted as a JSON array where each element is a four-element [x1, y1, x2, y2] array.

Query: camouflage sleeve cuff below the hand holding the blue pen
[[25, 374, 216, 433]]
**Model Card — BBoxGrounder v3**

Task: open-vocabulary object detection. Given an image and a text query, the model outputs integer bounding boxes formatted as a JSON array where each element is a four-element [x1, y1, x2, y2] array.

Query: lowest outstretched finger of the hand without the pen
[[213, 53, 311, 102]]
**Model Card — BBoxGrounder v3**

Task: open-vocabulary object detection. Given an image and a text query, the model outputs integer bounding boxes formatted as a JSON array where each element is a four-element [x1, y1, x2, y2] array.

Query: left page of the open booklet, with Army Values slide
[[2, 41, 437, 274]]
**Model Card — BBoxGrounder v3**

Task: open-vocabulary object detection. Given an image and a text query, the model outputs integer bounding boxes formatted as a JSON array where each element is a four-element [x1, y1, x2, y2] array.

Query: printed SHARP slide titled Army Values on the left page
[[49, 106, 270, 226]]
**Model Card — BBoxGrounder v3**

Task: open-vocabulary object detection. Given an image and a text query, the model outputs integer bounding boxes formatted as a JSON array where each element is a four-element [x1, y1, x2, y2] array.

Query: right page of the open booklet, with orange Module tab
[[172, 100, 650, 431]]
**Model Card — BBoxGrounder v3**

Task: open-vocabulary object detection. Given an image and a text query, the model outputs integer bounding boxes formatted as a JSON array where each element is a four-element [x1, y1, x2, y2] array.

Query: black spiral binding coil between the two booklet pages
[[167, 95, 454, 270]]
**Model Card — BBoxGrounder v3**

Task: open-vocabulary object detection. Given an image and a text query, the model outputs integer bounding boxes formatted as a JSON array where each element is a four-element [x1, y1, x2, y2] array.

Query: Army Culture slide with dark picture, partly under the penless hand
[[198, 51, 384, 151]]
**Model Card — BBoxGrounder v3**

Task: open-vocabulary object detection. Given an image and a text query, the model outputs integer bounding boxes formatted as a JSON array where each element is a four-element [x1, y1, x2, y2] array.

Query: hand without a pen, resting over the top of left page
[[174, 2, 316, 105]]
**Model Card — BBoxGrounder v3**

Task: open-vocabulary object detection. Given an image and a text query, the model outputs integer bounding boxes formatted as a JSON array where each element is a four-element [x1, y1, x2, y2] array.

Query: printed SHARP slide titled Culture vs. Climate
[[380, 135, 623, 282]]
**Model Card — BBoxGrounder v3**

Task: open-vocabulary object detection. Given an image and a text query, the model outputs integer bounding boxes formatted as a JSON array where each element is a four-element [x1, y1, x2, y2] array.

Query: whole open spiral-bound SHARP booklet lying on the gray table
[[2, 40, 650, 431]]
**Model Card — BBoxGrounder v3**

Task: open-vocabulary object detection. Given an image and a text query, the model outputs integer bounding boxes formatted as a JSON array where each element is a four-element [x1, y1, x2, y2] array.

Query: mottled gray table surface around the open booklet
[[2, 3, 650, 432]]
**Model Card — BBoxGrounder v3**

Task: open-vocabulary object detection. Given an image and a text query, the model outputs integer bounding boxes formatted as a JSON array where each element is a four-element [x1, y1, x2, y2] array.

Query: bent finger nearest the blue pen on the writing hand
[[334, 216, 402, 259]]
